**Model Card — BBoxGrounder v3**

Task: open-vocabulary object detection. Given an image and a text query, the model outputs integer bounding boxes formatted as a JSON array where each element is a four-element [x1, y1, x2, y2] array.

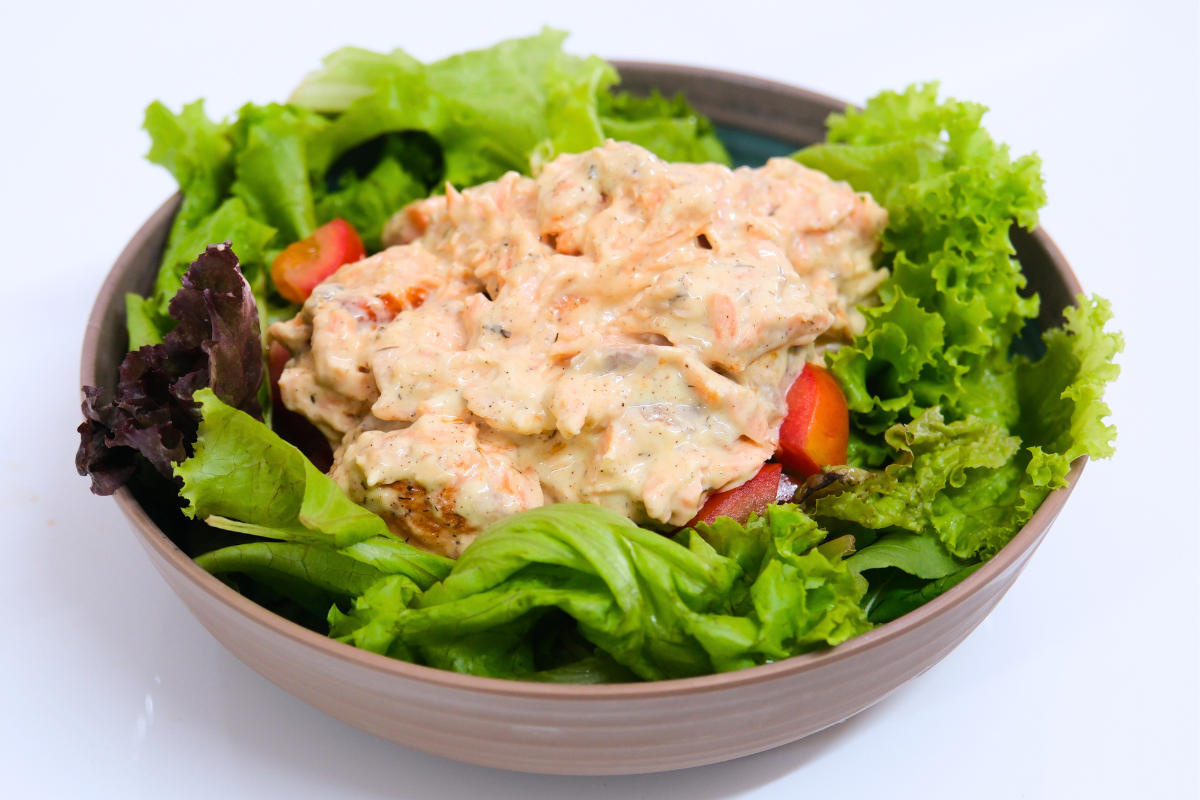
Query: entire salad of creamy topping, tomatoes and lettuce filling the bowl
[[77, 30, 1123, 682]]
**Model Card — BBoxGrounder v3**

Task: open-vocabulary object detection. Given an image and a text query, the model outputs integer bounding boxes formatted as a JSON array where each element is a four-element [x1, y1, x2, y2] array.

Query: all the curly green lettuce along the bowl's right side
[[794, 84, 1123, 568]]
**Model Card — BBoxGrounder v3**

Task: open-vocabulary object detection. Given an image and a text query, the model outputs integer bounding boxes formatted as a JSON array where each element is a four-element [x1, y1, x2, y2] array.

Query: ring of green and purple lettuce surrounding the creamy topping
[[77, 30, 1123, 682]]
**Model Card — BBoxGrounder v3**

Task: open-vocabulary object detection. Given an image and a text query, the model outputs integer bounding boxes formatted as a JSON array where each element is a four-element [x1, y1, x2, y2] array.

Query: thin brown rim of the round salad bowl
[[87, 61, 1087, 702]]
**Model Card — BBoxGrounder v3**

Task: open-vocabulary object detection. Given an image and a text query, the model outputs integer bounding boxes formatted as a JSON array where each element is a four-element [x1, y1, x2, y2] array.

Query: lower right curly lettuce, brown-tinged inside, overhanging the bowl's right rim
[[812, 292, 1124, 556]]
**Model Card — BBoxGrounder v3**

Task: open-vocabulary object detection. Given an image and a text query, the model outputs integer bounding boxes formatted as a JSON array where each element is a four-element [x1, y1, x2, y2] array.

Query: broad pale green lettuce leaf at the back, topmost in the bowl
[[292, 29, 617, 187]]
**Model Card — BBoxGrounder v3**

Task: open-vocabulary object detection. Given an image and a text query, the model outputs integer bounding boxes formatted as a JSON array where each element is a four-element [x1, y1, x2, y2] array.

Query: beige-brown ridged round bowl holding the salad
[[83, 64, 1085, 775]]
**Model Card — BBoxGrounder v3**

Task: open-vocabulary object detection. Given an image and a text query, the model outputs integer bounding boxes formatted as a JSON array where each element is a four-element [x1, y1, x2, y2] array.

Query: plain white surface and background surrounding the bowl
[[0, 0, 1200, 800]]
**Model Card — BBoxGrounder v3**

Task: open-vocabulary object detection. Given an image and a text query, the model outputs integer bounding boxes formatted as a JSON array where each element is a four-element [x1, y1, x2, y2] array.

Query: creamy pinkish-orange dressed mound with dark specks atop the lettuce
[[271, 142, 887, 555]]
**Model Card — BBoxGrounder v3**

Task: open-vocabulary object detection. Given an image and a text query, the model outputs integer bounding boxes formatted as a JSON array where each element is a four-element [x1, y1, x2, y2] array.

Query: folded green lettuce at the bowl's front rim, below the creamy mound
[[330, 504, 870, 680]]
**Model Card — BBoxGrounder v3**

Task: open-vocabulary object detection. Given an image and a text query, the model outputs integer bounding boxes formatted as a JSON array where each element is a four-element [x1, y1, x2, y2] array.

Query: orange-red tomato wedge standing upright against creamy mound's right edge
[[775, 363, 850, 477]]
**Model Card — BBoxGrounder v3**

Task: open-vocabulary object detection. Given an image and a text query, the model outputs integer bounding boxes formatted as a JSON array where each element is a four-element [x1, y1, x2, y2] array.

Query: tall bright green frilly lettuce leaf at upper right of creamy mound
[[793, 84, 1045, 435]]
